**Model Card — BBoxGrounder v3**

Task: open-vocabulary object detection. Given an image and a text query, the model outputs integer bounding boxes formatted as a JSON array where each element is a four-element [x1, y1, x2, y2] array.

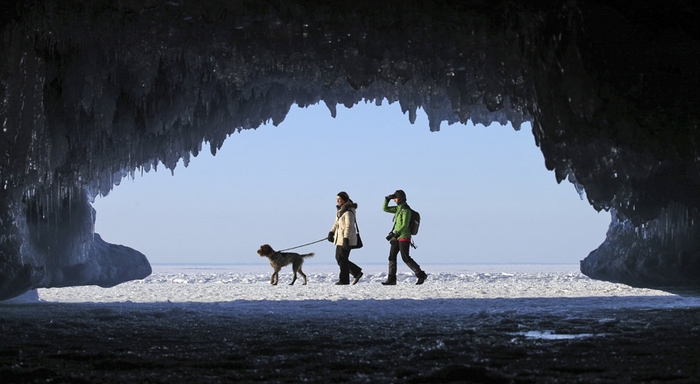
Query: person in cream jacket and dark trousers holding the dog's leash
[[328, 192, 362, 285]]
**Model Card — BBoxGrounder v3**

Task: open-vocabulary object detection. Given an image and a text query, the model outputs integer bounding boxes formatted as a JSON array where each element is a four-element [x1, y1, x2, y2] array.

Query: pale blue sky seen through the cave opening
[[93, 102, 610, 267]]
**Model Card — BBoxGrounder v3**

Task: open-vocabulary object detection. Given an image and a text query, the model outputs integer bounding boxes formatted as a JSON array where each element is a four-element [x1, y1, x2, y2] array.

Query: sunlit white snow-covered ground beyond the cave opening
[[39, 261, 688, 305]]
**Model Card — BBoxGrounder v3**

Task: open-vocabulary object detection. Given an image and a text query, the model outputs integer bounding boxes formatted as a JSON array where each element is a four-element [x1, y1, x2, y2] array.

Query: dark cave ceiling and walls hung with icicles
[[0, 0, 700, 299]]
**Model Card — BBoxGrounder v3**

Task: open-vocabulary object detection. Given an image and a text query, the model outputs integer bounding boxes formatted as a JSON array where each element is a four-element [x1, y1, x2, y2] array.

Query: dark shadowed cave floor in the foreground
[[0, 302, 700, 383]]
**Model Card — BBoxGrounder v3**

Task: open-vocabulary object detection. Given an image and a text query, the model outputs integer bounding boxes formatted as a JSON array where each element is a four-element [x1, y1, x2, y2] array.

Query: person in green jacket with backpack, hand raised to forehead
[[382, 189, 428, 285]]
